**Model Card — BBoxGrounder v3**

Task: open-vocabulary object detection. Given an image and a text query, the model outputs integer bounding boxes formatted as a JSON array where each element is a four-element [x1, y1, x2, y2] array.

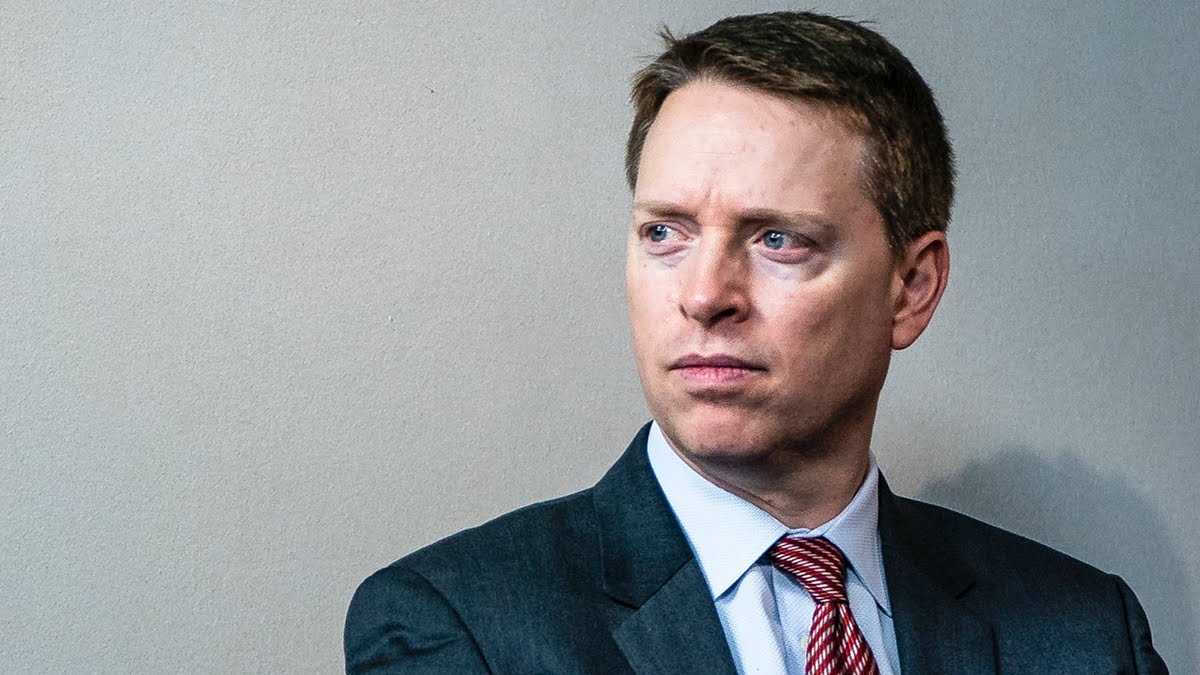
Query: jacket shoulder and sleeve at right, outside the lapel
[[880, 497, 1165, 673]]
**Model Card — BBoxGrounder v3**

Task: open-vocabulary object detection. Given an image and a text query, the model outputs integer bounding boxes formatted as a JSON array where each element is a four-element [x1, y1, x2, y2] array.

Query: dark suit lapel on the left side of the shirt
[[593, 424, 737, 675]]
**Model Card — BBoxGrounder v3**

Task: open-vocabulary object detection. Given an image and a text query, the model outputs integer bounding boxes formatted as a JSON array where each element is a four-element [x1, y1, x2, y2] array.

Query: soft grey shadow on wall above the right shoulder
[[919, 449, 1200, 673]]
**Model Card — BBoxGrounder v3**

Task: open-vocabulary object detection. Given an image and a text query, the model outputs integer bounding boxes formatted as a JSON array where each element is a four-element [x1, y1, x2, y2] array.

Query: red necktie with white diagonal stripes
[[767, 537, 880, 675]]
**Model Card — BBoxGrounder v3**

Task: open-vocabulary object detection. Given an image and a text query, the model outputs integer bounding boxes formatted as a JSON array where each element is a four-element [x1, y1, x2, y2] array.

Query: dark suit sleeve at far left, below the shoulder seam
[[344, 566, 491, 675]]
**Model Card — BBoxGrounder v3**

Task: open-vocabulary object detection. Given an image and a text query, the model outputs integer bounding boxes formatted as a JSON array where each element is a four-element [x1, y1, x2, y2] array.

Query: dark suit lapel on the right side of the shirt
[[880, 479, 997, 674]]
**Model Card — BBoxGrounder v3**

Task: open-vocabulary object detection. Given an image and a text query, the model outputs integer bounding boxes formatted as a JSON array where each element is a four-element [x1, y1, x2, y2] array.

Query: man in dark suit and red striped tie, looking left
[[346, 13, 1165, 674]]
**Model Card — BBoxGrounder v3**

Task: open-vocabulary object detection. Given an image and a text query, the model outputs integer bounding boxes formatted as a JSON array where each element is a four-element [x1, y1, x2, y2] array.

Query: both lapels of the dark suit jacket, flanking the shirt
[[593, 424, 997, 675]]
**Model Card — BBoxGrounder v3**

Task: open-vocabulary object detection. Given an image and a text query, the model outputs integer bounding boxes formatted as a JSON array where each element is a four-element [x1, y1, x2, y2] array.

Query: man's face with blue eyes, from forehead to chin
[[625, 82, 902, 462]]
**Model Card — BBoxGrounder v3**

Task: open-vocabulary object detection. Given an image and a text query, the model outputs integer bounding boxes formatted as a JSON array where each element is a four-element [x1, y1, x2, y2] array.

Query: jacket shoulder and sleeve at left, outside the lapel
[[346, 482, 614, 673]]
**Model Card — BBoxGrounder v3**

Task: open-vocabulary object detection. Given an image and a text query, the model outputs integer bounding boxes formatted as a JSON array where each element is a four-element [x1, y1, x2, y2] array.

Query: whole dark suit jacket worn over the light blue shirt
[[346, 425, 1166, 675]]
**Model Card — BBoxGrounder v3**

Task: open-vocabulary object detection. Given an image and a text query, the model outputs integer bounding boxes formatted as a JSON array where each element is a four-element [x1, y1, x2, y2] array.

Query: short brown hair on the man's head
[[625, 12, 954, 251]]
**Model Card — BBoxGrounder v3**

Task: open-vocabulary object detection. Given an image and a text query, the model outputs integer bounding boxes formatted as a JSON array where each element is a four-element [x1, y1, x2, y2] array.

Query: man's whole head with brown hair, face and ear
[[626, 14, 953, 465]]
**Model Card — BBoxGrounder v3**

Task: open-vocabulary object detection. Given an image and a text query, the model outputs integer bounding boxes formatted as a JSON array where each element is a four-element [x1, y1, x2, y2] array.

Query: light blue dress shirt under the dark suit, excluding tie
[[647, 423, 900, 675]]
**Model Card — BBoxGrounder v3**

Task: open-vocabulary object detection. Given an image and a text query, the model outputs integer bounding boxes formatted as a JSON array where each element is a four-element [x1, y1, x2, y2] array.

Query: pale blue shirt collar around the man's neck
[[646, 423, 892, 616]]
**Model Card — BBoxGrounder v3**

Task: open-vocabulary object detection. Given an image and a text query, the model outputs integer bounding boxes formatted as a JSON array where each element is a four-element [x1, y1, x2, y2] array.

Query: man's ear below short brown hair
[[892, 232, 950, 350]]
